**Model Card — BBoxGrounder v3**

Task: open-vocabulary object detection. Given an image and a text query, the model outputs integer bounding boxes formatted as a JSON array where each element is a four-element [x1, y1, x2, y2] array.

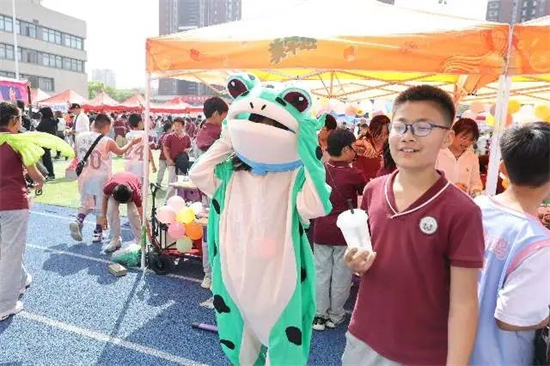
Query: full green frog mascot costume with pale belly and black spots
[[190, 74, 332, 365]]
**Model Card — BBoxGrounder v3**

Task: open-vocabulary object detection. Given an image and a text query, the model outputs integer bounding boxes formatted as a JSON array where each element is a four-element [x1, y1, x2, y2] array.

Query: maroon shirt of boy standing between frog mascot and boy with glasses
[[313, 160, 366, 245]]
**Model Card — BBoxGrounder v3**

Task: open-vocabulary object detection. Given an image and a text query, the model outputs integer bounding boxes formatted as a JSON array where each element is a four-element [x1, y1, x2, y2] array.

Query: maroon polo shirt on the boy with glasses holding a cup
[[349, 171, 484, 365]]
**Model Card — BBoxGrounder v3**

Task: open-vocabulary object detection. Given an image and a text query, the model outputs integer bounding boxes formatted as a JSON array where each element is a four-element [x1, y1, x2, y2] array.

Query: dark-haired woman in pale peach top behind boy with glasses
[[436, 118, 483, 197]]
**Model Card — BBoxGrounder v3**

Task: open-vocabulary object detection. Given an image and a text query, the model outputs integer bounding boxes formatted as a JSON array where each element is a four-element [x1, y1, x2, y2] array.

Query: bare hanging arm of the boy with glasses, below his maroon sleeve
[[447, 266, 479, 366]]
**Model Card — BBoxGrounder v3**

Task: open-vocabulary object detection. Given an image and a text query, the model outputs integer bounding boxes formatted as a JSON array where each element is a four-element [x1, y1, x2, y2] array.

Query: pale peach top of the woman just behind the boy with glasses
[[435, 149, 483, 194]]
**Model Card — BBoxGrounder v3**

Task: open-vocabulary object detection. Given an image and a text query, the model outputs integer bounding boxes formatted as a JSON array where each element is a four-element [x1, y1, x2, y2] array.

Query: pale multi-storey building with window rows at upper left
[[0, 0, 88, 97]]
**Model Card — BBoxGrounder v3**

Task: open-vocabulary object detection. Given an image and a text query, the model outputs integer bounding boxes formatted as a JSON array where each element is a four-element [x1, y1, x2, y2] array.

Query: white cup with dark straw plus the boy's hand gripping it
[[336, 200, 376, 274]]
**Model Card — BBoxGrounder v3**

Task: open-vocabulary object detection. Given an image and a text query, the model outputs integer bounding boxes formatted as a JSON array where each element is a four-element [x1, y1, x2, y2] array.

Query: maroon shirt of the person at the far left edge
[[0, 128, 29, 211]]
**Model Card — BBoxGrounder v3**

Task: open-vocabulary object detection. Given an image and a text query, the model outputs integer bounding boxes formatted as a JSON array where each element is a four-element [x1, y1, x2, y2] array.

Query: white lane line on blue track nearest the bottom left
[[17, 311, 205, 365]]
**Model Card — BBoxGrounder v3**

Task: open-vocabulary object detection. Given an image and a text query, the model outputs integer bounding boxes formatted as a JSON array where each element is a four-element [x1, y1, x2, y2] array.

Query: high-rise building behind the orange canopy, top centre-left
[[159, 0, 242, 95]]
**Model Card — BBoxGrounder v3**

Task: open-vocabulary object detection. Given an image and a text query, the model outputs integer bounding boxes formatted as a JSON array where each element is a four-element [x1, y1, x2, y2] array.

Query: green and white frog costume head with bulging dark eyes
[[226, 74, 324, 175]]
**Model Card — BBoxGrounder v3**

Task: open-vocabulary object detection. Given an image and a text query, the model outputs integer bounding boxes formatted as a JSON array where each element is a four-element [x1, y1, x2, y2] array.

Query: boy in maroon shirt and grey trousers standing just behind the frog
[[313, 129, 366, 330]]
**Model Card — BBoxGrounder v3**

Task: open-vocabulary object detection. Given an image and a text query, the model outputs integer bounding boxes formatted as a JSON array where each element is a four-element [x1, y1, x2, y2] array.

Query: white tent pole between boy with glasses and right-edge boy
[[485, 25, 514, 196]]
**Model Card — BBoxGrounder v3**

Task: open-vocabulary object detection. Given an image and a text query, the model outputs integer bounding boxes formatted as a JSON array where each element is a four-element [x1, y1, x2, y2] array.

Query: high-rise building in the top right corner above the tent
[[487, 0, 550, 24]]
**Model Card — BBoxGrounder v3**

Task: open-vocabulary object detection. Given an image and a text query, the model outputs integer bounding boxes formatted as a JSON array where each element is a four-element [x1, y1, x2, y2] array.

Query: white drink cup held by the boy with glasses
[[336, 208, 372, 251]]
